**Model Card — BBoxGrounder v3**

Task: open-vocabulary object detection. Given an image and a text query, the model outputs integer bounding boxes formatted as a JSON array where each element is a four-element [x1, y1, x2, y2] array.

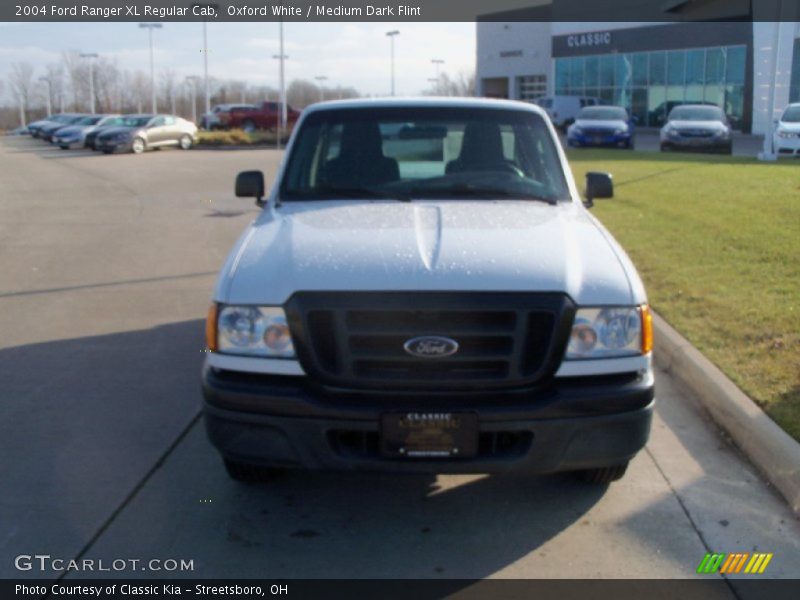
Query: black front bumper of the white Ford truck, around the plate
[[203, 367, 654, 473]]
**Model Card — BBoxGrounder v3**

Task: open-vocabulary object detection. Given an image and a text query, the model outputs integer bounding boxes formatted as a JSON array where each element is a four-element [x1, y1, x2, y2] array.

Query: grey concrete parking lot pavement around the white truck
[[0, 138, 800, 580]]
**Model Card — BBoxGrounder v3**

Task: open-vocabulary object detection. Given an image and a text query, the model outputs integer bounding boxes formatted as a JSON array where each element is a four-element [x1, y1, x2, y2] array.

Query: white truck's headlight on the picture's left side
[[214, 306, 295, 358]]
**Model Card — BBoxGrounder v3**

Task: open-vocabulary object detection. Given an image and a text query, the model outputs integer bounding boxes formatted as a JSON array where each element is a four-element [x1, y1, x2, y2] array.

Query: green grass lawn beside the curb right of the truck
[[568, 150, 800, 440]]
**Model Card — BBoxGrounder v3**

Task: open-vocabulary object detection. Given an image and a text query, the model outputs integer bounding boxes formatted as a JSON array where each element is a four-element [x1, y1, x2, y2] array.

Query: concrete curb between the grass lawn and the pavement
[[653, 314, 800, 514]]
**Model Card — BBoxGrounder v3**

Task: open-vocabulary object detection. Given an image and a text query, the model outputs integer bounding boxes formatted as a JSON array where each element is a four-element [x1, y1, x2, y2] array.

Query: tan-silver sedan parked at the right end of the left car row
[[94, 115, 197, 154]]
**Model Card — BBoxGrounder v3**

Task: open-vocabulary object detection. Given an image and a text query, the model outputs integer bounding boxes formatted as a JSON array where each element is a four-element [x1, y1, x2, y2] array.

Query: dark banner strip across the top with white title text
[[0, 0, 800, 22]]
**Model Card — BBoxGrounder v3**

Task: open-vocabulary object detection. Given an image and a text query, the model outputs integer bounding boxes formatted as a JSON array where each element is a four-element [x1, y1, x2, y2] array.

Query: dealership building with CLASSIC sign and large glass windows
[[476, 20, 800, 133]]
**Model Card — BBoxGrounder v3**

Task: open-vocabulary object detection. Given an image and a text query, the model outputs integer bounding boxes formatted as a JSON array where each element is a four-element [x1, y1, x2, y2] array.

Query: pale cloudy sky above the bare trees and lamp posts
[[0, 22, 475, 103]]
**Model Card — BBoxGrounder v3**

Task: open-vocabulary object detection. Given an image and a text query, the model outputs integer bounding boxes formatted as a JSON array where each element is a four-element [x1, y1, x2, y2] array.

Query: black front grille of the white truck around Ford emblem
[[286, 292, 574, 389]]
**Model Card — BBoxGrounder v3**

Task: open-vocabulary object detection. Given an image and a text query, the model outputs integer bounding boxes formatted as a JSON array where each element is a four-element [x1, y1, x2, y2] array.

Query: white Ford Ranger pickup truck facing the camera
[[203, 99, 653, 482]]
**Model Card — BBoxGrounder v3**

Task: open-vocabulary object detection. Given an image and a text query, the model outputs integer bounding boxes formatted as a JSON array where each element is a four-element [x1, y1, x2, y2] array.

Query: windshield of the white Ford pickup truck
[[280, 107, 569, 202]]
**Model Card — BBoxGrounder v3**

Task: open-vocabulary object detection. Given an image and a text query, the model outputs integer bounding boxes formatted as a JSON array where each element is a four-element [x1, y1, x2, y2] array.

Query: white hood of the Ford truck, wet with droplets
[[215, 200, 644, 305]]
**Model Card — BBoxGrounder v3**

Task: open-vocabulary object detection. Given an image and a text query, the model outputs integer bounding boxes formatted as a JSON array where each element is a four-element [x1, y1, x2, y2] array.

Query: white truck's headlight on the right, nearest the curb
[[566, 305, 653, 360]]
